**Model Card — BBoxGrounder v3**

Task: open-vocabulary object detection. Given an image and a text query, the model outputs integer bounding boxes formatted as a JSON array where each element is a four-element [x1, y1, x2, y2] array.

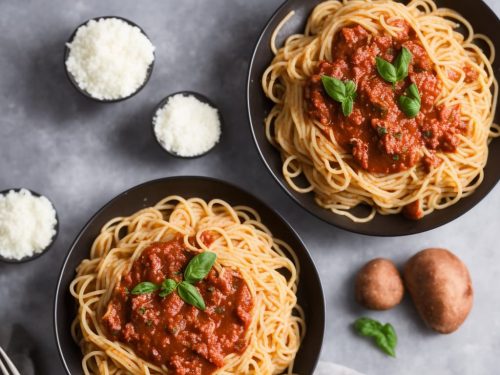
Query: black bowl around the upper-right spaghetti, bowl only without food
[[247, 0, 500, 236]]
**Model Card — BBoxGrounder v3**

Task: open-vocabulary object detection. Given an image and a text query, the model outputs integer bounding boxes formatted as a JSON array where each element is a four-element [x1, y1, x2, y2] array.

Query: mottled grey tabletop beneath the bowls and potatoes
[[0, 0, 500, 375]]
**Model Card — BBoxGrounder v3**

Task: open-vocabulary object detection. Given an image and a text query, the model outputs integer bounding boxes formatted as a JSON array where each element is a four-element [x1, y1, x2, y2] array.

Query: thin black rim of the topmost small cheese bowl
[[64, 16, 155, 103]]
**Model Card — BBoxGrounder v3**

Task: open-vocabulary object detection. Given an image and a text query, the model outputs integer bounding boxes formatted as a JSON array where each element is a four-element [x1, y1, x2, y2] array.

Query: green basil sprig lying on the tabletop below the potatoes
[[354, 318, 398, 357]]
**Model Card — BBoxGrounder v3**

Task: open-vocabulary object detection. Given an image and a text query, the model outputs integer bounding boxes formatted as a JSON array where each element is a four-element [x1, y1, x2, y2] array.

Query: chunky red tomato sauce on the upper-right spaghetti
[[306, 21, 466, 174]]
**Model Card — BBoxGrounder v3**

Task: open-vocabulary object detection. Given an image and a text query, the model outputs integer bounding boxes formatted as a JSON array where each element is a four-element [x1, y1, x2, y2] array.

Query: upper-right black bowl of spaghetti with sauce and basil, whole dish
[[247, 0, 500, 236]]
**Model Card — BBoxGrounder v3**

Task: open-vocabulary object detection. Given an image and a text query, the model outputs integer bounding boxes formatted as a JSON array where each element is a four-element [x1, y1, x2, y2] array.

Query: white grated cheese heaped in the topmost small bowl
[[66, 18, 155, 100]]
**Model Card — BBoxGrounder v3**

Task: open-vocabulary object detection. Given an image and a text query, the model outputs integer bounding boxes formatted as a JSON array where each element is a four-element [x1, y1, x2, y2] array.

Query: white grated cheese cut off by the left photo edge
[[0, 189, 57, 260]]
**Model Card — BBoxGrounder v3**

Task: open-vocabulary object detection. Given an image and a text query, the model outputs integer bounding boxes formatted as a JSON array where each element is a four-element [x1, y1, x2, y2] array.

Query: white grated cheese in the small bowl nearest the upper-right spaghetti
[[153, 94, 221, 157]]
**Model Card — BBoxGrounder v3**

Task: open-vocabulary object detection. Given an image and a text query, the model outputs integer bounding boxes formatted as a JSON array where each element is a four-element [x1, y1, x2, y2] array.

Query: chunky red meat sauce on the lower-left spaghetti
[[102, 238, 253, 375]]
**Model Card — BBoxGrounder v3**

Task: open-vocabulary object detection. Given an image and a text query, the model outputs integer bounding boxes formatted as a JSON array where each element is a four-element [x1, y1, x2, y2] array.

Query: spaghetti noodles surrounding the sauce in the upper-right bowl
[[262, 0, 500, 222]]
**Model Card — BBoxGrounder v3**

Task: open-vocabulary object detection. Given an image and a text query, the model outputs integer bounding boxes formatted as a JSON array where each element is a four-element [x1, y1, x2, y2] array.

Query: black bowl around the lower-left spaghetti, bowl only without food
[[54, 176, 325, 375]]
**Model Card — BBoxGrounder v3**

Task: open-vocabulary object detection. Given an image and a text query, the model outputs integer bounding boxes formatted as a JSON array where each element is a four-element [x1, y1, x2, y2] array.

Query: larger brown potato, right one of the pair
[[403, 249, 473, 333]]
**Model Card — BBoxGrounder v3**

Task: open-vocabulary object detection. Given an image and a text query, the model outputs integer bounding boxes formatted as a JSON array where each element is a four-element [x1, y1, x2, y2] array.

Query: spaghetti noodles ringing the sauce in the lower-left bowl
[[70, 196, 305, 375]]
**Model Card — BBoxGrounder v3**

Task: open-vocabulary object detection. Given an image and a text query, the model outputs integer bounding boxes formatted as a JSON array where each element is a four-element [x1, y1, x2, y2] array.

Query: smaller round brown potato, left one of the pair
[[355, 258, 404, 310]]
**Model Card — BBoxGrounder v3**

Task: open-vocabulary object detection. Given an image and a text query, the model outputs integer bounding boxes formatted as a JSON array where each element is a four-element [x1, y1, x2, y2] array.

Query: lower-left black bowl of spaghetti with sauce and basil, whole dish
[[54, 177, 325, 375]]
